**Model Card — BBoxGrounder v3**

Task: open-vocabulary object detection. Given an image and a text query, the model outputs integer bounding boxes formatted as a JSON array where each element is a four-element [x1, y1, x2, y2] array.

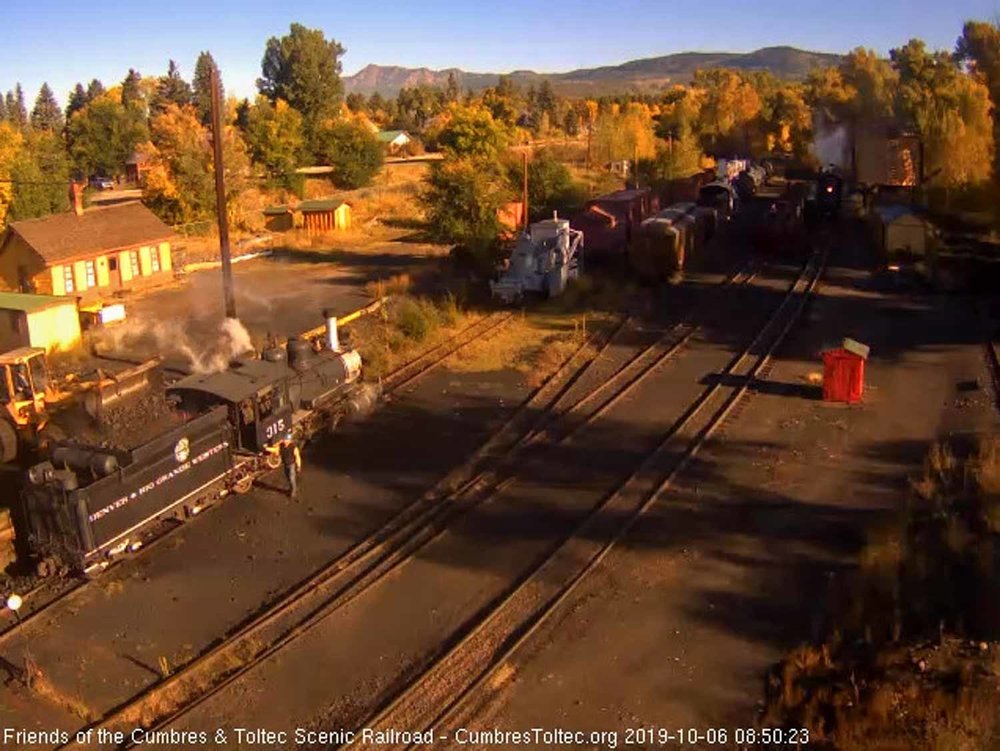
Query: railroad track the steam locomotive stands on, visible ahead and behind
[[0, 311, 515, 645]]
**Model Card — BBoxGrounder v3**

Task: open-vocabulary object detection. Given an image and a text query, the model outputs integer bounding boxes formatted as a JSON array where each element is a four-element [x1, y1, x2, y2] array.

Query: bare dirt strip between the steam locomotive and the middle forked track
[[0, 362, 527, 748]]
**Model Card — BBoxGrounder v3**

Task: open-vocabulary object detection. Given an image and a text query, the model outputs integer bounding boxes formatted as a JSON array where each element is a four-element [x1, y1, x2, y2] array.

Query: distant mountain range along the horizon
[[344, 47, 841, 97]]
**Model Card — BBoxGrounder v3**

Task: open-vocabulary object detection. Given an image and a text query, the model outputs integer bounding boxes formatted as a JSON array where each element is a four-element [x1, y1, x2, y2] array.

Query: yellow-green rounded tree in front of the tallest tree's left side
[[244, 95, 305, 188]]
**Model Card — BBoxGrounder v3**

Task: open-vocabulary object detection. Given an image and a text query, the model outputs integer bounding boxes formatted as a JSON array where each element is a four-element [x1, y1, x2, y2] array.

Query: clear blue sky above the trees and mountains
[[0, 0, 1000, 106]]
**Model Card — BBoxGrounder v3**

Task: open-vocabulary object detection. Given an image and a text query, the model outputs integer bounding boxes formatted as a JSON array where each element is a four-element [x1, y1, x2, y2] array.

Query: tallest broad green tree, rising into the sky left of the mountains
[[257, 23, 344, 137]]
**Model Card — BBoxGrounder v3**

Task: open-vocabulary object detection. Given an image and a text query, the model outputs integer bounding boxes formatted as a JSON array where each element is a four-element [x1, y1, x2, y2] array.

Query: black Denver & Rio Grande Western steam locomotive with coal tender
[[16, 339, 375, 576]]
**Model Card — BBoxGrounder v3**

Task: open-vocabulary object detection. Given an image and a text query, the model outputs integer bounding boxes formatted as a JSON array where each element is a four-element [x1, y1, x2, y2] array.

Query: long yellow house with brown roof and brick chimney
[[0, 201, 176, 300]]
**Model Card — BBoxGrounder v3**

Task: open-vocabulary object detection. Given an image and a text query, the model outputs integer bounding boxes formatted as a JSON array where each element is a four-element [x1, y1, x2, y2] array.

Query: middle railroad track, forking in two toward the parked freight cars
[[56, 262, 755, 745]]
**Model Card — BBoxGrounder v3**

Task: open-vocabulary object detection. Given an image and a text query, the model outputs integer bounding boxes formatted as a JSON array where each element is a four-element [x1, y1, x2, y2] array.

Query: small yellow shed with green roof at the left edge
[[0, 292, 80, 352]]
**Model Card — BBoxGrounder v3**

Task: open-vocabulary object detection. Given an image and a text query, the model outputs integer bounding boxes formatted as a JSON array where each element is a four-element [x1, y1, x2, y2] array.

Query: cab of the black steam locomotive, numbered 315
[[167, 359, 292, 454]]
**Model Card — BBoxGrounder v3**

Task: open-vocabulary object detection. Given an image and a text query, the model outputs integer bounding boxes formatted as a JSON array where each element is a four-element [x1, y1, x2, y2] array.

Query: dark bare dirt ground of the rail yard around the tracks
[[0, 213, 997, 748]]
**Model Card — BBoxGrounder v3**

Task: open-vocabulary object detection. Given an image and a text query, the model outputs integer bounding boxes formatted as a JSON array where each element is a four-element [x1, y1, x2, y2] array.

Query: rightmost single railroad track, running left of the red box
[[347, 253, 826, 748]]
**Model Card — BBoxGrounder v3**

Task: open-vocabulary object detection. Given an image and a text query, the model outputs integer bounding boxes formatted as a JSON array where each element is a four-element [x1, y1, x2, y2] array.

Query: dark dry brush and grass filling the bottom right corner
[[764, 436, 1000, 751]]
